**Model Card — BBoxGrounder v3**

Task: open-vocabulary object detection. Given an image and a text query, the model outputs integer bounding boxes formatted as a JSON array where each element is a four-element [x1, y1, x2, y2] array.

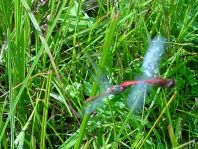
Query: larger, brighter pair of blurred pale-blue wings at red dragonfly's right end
[[128, 36, 165, 112]]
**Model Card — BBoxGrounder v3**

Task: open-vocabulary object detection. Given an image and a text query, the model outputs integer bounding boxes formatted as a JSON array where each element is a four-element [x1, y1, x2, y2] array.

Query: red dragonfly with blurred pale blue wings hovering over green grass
[[85, 36, 175, 114]]
